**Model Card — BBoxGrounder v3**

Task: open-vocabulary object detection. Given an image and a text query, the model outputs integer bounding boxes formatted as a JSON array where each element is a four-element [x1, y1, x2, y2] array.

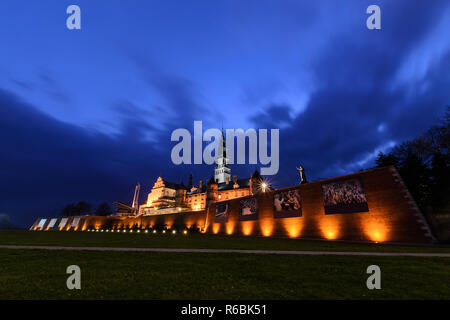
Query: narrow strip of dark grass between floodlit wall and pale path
[[0, 230, 450, 253]]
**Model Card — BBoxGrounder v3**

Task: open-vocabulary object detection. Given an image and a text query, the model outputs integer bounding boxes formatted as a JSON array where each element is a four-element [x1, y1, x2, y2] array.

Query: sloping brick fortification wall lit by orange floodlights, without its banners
[[32, 167, 434, 243]]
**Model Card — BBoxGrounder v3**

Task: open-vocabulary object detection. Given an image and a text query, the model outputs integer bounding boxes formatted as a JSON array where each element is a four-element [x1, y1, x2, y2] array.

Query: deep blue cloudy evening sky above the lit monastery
[[0, 0, 450, 226]]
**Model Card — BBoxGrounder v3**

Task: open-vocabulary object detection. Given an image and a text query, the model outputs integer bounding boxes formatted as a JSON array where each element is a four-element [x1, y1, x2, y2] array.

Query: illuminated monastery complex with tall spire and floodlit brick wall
[[30, 134, 436, 243]]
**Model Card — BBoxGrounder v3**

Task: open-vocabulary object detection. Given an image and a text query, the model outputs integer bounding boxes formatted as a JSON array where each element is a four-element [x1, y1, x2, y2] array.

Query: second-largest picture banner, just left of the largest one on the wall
[[273, 189, 302, 218]]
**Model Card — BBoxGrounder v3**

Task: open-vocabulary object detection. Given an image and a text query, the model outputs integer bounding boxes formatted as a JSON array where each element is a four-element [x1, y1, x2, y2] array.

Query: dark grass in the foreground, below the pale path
[[0, 249, 450, 299]]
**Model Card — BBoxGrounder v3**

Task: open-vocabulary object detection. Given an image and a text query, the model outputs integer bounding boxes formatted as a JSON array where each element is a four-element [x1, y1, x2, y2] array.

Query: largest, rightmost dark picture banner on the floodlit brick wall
[[322, 178, 369, 214]]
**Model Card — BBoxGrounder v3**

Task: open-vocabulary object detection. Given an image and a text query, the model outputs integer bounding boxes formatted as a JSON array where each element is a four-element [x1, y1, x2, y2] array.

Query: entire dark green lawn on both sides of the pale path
[[0, 230, 450, 299]]
